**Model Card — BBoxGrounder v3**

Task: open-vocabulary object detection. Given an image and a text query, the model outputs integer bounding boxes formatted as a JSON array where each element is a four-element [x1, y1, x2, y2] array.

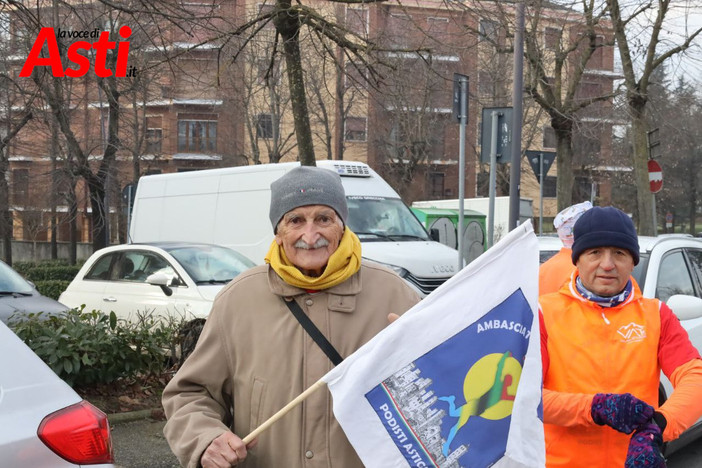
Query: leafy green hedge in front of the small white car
[[9, 308, 183, 387]]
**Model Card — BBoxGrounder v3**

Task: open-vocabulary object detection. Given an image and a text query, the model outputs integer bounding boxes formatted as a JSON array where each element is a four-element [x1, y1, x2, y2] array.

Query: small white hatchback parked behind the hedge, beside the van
[[59, 242, 254, 319]]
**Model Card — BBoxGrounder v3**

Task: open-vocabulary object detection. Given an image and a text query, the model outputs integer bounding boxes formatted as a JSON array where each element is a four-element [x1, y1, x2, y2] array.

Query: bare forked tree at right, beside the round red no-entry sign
[[606, 0, 702, 235]]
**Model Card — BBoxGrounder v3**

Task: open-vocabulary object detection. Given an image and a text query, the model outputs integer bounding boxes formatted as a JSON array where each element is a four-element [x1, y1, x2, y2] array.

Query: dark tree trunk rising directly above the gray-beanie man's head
[[274, 0, 317, 166]]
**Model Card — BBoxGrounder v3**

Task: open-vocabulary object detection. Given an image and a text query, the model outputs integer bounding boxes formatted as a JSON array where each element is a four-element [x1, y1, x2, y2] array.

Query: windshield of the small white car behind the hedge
[[165, 245, 254, 284]]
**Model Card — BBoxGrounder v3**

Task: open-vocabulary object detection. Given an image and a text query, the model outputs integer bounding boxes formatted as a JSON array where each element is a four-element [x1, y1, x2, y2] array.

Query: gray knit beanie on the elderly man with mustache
[[269, 166, 349, 232]]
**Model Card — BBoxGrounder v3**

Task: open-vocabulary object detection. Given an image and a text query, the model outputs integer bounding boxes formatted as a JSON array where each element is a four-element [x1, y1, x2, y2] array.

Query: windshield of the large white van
[[346, 196, 431, 242]]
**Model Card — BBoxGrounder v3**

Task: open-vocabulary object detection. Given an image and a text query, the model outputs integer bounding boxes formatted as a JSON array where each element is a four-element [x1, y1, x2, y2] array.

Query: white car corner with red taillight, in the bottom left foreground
[[0, 322, 114, 468]]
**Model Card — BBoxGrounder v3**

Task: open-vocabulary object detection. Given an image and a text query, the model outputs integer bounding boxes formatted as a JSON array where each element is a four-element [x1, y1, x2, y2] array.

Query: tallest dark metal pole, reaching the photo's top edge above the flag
[[509, 1, 524, 231]]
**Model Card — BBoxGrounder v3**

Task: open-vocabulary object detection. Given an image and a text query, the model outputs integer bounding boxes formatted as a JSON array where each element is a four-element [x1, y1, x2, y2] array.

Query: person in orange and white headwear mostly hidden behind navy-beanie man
[[539, 201, 592, 294]]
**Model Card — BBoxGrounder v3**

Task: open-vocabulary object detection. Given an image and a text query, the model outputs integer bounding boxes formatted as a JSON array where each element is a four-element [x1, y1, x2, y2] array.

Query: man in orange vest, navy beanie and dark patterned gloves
[[539, 207, 702, 468]]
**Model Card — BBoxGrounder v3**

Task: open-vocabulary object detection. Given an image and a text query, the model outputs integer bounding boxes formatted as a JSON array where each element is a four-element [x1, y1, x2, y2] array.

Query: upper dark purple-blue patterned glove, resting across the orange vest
[[590, 393, 654, 434]]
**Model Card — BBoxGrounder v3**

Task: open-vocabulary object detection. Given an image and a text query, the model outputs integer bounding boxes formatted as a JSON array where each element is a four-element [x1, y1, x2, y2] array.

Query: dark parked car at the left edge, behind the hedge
[[0, 261, 68, 323]]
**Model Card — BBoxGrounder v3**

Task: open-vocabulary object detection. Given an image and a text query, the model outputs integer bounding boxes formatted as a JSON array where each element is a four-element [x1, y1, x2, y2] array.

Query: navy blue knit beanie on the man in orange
[[571, 206, 639, 265]]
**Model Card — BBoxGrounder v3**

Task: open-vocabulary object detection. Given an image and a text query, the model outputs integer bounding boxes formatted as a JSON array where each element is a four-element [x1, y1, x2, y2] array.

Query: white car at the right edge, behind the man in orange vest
[[633, 235, 702, 454]]
